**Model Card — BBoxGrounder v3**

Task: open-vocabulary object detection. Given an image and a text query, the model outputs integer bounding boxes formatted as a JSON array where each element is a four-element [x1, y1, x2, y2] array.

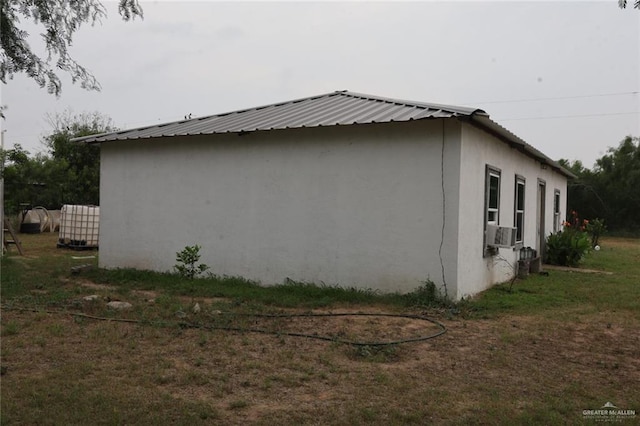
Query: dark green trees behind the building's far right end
[[560, 136, 640, 235]]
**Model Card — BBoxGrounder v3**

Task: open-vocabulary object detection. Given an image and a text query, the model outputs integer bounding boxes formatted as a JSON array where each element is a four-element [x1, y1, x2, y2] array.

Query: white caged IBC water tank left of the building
[[58, 204, 100, 248]]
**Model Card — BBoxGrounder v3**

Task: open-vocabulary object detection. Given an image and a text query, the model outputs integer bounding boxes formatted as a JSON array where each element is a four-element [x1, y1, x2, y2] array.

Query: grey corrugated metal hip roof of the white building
[[74, 90, 574, 177]]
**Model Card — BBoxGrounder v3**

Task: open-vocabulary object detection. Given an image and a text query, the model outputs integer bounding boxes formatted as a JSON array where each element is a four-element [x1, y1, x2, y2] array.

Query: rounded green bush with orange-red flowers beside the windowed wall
[[545, 210, 591, 266]]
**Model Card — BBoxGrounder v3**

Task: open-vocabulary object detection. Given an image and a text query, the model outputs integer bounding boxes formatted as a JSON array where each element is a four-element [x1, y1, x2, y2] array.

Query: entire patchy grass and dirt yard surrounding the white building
[[0, 234, 640, 425]]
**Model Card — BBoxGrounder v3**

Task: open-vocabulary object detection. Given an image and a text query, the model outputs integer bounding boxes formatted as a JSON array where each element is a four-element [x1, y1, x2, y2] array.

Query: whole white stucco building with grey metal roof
[[79, 92, 571, 299]]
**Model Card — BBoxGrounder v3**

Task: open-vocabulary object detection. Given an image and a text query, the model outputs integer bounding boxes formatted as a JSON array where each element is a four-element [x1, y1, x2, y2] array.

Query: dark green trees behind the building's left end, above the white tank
[[2, 112, 111, 215]]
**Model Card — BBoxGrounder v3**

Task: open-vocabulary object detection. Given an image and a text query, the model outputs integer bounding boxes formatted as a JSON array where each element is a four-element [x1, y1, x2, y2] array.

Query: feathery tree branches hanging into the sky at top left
[[0, 0, 142, 96]]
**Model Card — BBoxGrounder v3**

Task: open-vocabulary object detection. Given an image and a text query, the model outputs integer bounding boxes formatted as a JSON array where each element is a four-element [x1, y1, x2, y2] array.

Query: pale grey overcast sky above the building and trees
[[1, 0, 640, 167]]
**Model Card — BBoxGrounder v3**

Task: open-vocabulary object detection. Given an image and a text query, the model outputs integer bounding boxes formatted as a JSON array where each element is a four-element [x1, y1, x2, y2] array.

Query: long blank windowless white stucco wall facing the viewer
[[100, 120, 462, 294]]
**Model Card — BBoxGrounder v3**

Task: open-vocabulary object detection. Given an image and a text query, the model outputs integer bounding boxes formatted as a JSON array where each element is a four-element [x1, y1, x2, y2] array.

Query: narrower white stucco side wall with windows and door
[[456, 124, 567, 298]]
